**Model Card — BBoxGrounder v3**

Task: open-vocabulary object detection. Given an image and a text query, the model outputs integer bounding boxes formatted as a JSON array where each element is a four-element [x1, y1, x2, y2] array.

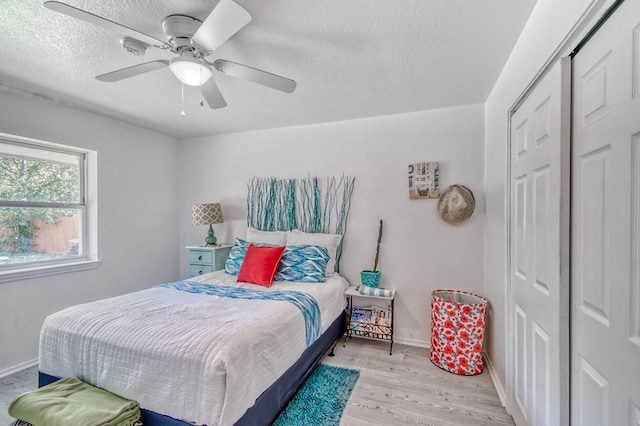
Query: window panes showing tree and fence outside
[[0, 134, 95, 276]]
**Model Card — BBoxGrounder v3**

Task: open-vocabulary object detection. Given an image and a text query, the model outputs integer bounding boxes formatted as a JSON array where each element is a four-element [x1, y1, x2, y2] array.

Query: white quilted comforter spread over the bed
[[39, 271, 348, 425]]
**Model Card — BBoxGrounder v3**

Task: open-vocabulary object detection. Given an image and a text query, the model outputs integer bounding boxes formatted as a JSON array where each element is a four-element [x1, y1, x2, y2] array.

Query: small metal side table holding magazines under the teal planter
[[343, 285, 396, 355]]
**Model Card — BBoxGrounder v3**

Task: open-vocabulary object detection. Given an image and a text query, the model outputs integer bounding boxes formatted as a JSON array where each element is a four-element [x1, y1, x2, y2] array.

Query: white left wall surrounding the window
[[0, 87, 179, 376]]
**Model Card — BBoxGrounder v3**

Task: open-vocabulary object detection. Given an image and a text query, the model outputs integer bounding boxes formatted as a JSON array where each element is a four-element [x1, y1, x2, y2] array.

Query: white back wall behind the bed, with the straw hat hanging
[[179, 105, 484, 345]]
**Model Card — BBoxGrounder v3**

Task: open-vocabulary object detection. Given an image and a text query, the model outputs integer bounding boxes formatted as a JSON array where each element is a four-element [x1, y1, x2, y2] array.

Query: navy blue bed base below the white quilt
[[38, 311, 346, 426]]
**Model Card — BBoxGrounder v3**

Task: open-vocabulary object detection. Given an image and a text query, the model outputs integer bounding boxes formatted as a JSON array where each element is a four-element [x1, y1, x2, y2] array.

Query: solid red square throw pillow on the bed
[[238, 244, 285, 287]]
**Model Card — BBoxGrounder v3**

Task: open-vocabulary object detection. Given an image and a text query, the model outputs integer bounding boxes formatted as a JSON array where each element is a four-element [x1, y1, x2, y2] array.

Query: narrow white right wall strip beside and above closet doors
[[484, 0, 610, 396]]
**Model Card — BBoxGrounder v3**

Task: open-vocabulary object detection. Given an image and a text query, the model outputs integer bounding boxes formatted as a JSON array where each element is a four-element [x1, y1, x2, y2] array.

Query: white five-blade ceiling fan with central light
[[44, 0, 296, 108]]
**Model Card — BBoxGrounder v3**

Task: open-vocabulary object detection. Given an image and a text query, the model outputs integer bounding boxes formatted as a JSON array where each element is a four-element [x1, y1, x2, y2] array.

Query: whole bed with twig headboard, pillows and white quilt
[[39, 176, 354, 426]]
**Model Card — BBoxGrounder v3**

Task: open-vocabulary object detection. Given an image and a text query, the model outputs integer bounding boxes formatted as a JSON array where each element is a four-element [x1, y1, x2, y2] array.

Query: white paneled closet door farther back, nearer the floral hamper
[[507, 63, 569, 426]]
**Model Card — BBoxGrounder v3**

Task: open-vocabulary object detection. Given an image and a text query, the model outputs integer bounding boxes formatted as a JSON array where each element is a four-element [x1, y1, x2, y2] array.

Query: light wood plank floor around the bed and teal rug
[[0, 339, 513, 426]]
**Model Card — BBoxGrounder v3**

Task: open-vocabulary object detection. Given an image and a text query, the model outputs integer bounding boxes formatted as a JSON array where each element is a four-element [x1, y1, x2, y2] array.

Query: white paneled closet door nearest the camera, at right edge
[[571, 0, 640, 426]]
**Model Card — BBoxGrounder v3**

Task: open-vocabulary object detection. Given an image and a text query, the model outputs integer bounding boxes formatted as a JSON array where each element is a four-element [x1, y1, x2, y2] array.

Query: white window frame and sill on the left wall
[[0, 133, 101, 283]]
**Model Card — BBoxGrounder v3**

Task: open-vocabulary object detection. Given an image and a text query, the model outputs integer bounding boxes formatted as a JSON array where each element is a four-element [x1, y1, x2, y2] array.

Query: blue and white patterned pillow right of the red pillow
[[274, 245, 329, 283]]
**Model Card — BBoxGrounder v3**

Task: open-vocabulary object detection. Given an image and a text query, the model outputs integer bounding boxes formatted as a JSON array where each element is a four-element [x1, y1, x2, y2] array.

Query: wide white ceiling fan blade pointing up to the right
[[191, 0, 251, 52]]
